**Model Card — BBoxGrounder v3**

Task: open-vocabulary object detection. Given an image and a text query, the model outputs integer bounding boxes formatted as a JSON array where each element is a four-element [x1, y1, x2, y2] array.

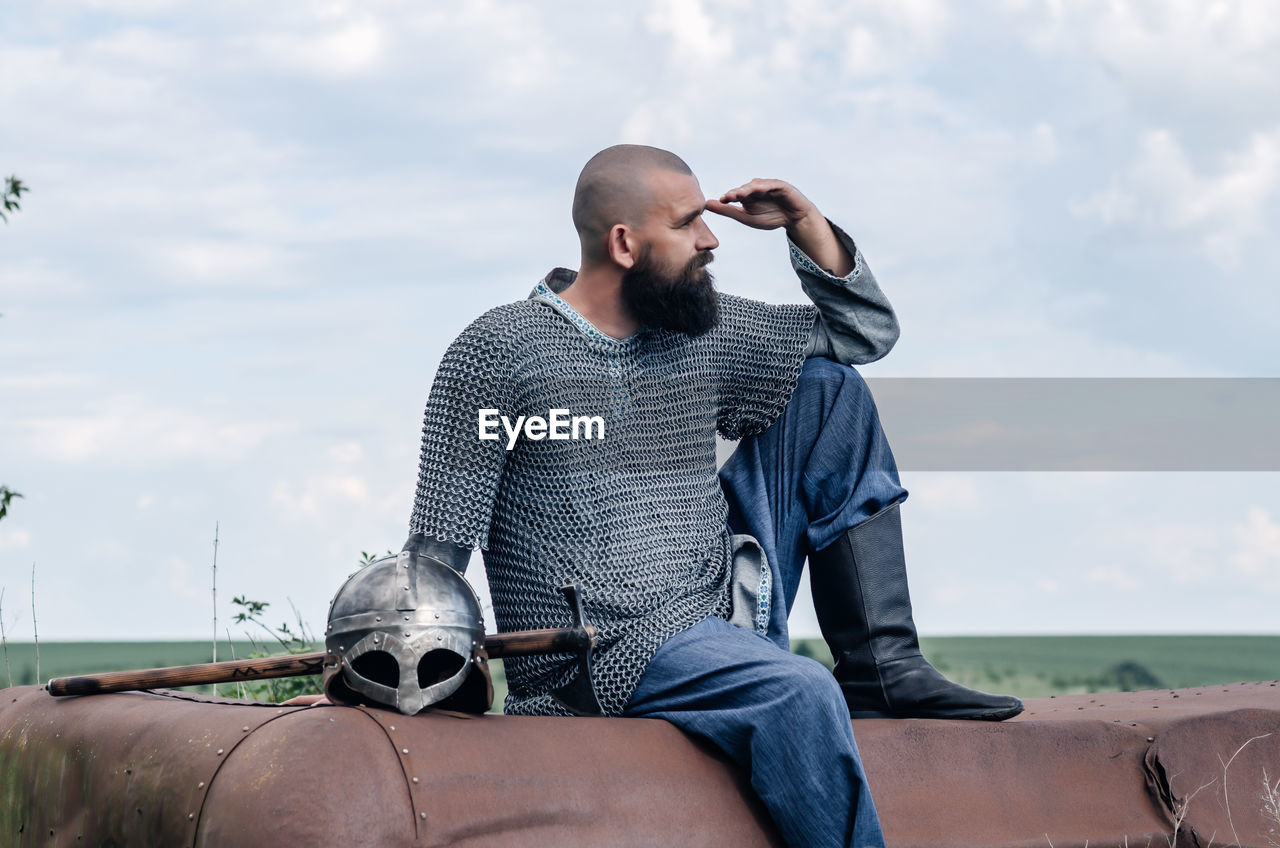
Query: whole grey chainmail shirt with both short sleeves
[[410, 280, 817, 716]]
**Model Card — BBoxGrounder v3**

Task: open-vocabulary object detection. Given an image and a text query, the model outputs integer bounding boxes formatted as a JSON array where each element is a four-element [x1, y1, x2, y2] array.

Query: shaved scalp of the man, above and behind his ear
[[573, 145, 694, 261]]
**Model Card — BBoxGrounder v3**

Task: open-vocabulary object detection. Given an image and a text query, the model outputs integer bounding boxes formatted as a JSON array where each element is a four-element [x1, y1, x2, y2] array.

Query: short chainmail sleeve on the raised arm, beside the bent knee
[[712, 295, 818, 439]]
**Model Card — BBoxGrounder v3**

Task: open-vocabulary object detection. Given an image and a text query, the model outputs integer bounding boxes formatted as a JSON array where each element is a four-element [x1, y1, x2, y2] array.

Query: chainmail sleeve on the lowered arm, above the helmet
[[410, 305, 515, 550]]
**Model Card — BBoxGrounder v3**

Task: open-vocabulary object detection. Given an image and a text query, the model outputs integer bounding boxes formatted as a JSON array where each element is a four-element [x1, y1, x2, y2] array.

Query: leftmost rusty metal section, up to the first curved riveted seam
[[0, 687, 294, 845]]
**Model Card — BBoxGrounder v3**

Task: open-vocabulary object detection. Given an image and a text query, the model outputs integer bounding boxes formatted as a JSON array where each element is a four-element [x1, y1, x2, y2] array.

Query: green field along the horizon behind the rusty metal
[[0, 635, 1280, 705]]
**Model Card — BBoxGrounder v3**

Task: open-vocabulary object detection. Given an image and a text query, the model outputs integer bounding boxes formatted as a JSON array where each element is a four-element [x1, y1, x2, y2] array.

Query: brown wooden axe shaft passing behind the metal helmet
[[45, 624, 596, 696]]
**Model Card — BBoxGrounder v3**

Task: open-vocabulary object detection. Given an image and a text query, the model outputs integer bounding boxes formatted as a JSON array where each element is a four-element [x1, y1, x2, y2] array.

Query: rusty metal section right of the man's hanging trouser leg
[[854, 681, 1280, 848]]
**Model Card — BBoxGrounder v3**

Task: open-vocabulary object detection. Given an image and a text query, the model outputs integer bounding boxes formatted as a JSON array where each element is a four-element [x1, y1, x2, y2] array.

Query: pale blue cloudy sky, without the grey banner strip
[[0, 0, 1280, 640]]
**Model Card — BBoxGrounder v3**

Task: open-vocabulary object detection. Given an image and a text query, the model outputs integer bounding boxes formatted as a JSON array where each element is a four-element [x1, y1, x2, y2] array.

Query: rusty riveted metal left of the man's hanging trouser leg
[[0, 687, 782, 848]]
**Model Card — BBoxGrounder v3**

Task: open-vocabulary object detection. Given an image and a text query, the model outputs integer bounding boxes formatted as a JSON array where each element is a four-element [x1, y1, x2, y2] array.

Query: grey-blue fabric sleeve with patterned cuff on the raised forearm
[[787, 222, 899, 365]]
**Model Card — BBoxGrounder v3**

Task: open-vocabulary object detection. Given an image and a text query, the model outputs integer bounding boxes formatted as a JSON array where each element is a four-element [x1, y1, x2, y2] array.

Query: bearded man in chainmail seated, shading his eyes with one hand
[[406, 145, 1021, 845]]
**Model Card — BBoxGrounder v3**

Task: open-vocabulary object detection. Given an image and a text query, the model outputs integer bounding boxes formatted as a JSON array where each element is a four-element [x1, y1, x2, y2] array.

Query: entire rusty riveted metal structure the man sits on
[[0, 683, 1280, 848]]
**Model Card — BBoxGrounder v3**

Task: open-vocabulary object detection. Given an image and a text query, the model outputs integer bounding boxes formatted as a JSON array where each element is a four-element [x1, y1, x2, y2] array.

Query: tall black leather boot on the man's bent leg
[[809, 503, 1023, 721]]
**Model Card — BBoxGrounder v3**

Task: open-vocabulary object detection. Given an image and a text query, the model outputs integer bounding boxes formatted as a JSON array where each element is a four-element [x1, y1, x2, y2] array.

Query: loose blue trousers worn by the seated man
[[626, 359, 906, 848]]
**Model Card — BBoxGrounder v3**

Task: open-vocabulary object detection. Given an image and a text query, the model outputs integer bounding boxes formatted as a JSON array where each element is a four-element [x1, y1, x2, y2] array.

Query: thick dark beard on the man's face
[[622, 245, 719, 337]]
